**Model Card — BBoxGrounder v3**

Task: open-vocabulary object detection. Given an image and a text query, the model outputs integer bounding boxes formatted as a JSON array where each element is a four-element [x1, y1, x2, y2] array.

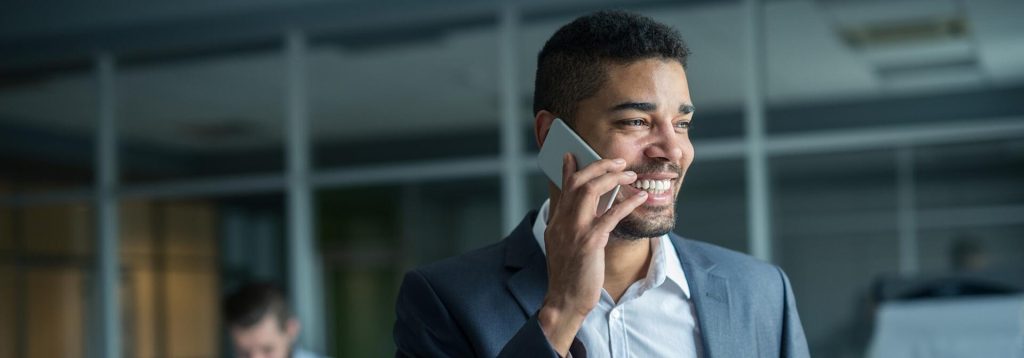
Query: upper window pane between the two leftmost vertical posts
[[117, 48, 285, 184]]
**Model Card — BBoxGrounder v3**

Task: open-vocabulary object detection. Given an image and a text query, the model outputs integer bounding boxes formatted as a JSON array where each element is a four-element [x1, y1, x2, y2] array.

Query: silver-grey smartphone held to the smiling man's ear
[[537, 119, 618, 215]]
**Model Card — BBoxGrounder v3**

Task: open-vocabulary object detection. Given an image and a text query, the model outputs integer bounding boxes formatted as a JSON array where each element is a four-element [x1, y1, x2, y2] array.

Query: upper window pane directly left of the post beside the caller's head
[[308, 24, 503, 168]]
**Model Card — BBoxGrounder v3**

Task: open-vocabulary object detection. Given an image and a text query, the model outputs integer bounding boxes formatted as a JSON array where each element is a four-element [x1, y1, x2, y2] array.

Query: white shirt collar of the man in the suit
[[534, 199, 690, 299]]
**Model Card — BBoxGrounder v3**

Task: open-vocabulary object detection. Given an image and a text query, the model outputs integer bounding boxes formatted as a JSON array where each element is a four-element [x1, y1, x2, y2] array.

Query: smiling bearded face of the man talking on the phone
[[571, 58, 693, 239]]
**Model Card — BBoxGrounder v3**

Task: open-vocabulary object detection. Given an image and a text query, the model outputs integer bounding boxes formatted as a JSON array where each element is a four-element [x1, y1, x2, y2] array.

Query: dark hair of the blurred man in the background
[[223, 282, 293, 330]]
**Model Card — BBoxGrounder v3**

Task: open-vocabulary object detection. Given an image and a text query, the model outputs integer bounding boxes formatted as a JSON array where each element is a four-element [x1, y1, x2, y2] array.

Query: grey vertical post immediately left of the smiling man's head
[[498, 2, 526, 233]]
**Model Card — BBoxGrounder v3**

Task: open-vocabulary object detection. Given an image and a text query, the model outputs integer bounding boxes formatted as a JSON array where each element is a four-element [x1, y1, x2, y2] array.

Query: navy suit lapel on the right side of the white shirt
[[670, 234, 735, 357]]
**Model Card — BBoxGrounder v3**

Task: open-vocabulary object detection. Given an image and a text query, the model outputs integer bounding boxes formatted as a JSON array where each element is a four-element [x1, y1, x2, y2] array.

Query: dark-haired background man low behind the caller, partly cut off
[[223, 283, 316, 358]]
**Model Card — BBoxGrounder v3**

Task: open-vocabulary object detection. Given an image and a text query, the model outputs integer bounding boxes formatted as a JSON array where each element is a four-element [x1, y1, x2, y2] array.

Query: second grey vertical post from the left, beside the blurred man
[[285, 30, 327, 352]]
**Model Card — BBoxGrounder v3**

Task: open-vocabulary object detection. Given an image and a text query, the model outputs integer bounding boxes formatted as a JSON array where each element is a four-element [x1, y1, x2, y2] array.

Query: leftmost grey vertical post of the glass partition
[[92, 53, 121, 358]]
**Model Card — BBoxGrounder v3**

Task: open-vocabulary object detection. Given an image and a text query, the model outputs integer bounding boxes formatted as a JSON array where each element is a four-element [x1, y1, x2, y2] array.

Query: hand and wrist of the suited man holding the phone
[[538, 153, 647, 356]]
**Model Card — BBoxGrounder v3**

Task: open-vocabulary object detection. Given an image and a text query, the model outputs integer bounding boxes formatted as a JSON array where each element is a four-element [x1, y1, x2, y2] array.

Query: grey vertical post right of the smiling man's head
[[744, 0, 772, 262]]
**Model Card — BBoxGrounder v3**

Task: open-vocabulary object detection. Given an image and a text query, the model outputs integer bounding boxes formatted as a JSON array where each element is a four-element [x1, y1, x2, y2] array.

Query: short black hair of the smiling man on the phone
[[534, 10, 690, 124]]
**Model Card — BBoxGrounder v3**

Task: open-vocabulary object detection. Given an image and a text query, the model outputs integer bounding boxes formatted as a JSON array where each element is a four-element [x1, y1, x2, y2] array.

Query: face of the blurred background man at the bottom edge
[[231, 314, 299, 358]]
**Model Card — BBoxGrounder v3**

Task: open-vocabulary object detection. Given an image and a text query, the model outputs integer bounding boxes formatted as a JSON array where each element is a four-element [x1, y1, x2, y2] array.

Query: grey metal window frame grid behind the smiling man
[[0, 0, 1024, 357]]
